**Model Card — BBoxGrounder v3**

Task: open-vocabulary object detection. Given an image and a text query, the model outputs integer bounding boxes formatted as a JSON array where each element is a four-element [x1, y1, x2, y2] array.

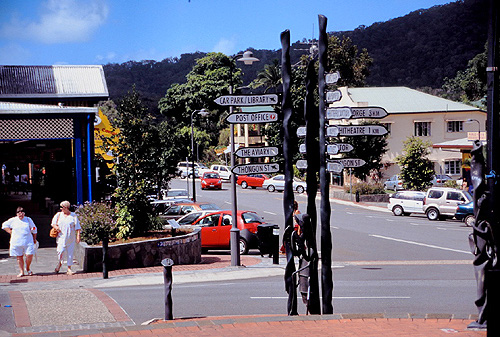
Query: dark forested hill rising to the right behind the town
[[104, 0, 488, 107]]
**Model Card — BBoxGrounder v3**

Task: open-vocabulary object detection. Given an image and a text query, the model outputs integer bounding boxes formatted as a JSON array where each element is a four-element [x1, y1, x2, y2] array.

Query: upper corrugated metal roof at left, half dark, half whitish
[[0, 65, 109, 98]]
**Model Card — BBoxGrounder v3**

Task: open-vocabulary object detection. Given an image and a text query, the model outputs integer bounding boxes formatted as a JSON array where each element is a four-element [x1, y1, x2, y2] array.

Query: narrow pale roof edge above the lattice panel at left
[[0, 102, 98, 115]]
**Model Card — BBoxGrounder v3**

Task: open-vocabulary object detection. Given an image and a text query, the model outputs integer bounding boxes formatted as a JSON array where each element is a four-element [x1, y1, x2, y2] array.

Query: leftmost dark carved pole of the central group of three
[[281, 30, 298, 315]]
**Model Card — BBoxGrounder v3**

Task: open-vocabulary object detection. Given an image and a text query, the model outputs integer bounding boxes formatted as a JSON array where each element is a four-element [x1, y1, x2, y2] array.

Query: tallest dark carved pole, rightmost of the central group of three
[[318, 15, 333, 315]]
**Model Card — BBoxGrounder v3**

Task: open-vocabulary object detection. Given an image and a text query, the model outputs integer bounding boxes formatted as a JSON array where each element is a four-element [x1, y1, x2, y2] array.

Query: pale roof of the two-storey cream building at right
[[333, 87, 481, 114]]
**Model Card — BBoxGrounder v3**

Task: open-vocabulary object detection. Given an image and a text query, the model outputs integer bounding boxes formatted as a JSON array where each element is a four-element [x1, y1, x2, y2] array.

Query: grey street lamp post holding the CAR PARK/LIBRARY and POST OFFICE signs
[[229, 50, 259, 266]]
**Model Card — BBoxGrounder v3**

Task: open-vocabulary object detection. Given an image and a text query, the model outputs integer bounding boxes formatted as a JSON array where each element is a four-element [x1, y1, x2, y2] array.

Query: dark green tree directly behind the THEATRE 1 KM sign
[[340, 121, 388, 180]]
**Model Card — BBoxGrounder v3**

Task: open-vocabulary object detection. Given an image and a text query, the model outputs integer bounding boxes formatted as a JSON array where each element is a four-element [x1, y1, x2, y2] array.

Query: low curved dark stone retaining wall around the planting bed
[[75, 226, 201, 272]]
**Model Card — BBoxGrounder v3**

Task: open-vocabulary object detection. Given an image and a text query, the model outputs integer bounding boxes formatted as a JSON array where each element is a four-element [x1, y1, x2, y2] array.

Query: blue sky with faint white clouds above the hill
[[0, 0, 452, 65]]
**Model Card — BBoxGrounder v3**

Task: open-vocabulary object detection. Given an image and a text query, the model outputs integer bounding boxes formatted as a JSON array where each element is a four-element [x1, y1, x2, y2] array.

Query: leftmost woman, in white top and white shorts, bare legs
[[2, 207, 37, 277]]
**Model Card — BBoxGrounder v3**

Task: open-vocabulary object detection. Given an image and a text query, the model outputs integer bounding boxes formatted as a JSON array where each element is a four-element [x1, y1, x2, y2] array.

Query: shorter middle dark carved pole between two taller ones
[[304, 60, 321, 315]]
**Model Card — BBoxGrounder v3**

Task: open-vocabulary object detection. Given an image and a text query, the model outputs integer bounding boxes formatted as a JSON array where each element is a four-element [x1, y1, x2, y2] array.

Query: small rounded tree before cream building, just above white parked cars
[[396, 136, 434, 191]]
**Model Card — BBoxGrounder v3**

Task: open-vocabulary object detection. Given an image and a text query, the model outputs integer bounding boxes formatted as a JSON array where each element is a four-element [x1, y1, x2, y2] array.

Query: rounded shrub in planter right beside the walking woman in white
[[76, 202, 117, 245]]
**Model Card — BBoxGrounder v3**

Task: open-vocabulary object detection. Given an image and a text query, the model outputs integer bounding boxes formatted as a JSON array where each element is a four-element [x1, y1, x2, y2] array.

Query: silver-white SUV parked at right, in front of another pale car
[[424, 187, 472, 220]]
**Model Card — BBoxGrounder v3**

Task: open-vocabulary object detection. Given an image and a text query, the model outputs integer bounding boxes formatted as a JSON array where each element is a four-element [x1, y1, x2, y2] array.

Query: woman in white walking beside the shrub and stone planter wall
[[51, 201, 82, 275]]
